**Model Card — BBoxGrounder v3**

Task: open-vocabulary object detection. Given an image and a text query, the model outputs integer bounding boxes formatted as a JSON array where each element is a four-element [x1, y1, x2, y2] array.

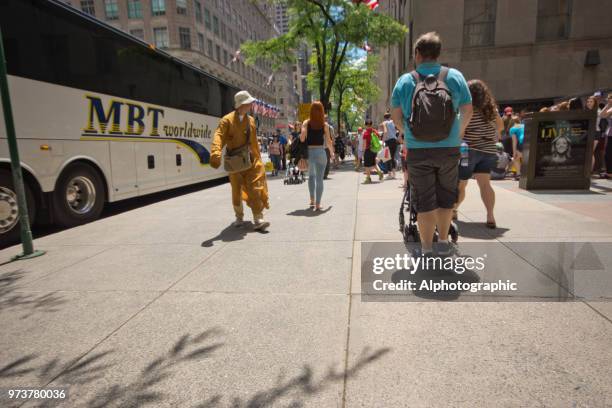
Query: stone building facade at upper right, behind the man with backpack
[[371, 0, 612, 118]]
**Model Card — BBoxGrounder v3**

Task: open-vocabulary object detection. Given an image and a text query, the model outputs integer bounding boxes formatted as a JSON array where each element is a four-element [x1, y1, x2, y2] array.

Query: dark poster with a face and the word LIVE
[[535, 119, 589, 179]]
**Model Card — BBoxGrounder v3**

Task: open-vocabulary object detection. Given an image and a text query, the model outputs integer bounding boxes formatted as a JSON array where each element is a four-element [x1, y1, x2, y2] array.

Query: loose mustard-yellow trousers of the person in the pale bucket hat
[[229, 160, 270, 218]]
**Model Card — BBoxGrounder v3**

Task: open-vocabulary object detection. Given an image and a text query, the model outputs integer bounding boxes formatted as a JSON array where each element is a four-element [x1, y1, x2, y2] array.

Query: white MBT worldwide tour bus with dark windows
[[0, 0, 238, 242]]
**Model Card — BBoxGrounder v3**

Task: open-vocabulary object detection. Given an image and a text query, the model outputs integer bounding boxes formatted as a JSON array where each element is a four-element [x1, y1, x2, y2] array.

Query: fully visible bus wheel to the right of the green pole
[[53, 163, 105, 227]]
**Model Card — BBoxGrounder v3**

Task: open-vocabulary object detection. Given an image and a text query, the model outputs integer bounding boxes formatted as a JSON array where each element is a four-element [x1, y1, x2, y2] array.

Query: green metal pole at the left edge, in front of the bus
[[0, 30, 44, 259]]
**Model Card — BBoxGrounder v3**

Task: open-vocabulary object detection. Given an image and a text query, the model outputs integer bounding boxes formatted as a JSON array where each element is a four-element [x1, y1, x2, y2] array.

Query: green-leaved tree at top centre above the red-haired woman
[[241, 0, 407, 110]]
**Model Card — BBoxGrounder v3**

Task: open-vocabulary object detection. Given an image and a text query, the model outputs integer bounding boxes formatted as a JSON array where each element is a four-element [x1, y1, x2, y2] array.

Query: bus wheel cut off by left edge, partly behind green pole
[[0, 170, 36, 246]]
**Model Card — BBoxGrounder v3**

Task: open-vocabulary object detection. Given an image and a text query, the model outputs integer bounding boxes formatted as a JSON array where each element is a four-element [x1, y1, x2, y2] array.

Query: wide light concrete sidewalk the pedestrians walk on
[[0, 165, 612, 407]]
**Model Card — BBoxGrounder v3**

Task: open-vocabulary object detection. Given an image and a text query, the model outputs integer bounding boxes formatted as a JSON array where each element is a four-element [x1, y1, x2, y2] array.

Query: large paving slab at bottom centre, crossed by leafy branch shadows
[[41, 292, 348, 408]]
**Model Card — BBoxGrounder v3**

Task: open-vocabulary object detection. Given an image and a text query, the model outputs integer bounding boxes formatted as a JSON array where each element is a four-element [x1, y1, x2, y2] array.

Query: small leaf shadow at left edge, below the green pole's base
[[0, 269, 67, 319]]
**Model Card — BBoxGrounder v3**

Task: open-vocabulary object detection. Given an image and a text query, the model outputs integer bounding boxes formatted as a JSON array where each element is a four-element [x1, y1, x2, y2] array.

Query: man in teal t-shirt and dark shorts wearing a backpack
[[391, 32, 472, 256]]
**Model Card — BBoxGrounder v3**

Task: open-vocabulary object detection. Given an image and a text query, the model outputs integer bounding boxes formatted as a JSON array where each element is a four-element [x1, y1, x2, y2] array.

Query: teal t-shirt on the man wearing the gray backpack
[[391, 62, 472, 149]]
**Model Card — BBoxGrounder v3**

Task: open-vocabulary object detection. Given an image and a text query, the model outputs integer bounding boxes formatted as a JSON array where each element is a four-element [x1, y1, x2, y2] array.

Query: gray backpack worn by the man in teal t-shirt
[[410, 67, 457, 142]]
